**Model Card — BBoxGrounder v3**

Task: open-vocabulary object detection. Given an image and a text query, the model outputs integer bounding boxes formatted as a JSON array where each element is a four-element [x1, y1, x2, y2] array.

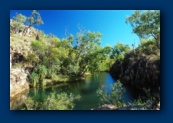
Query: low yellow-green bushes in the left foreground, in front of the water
[[23, 93, 81, 110]]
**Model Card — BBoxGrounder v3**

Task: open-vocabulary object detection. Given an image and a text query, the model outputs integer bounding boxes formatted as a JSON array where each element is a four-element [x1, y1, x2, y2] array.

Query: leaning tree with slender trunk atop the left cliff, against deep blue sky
[[23, 10, 44, 35]]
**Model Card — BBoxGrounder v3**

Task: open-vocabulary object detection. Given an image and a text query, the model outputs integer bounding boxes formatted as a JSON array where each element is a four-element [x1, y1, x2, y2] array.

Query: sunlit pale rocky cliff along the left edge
[[10, 20, 38, 99]]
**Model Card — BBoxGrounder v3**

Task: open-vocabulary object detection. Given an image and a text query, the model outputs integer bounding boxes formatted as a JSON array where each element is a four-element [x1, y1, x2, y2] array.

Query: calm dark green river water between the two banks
[[10, 72, 141, 110]]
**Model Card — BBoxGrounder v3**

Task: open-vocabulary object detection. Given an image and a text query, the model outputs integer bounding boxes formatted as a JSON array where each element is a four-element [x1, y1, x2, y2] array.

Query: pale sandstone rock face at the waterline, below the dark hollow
[[10, 68, 29, 98]]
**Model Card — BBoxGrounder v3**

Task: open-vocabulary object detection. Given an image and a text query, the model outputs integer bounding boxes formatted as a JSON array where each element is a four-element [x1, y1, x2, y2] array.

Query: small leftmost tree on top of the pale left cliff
[[14, 14, 26, 33]]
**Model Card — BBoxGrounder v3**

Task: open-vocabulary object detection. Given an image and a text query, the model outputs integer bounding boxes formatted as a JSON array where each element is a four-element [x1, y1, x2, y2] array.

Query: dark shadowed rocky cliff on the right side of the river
[[110, 49, 160, 98]]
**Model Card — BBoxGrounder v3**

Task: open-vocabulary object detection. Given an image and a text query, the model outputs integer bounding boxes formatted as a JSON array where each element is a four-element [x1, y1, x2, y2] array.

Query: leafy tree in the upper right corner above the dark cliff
[[126, 10, 160, 49]]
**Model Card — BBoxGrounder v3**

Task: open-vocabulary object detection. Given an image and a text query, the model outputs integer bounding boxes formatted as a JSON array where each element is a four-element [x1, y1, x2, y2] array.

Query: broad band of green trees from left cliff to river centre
[[28, 31, 112, 78]]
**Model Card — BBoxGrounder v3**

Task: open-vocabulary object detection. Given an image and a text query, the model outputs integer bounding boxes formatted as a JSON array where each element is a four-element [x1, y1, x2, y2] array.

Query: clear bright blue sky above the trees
[[10, 10, 139, 46]]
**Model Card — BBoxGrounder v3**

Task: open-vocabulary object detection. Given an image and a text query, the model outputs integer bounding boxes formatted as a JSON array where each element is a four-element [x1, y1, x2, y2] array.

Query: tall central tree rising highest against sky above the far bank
[[76, 31, 102, 75]]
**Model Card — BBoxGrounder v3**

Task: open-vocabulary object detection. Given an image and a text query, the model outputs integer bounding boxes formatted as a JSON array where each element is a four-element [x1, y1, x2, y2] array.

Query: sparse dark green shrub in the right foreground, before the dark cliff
[[97, 80, 152, 110]]
